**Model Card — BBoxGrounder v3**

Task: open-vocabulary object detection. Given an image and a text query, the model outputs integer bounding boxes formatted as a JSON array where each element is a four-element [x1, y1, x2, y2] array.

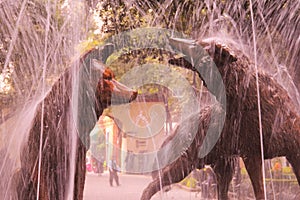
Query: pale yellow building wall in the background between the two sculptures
[[98, 102, 171, 169]]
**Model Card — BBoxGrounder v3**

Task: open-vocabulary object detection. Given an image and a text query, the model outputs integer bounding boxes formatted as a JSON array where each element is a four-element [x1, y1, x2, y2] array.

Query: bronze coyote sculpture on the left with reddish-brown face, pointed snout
[[13, 46, 137, 200]]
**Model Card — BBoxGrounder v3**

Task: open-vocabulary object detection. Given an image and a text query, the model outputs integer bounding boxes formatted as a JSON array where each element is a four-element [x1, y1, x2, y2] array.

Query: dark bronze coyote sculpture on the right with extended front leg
[[141, 39, 300, 200]]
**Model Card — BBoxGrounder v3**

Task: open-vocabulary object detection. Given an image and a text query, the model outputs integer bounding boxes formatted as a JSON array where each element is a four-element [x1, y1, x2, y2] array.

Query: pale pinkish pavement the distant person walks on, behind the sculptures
[[83, 171, 201, 200]]
